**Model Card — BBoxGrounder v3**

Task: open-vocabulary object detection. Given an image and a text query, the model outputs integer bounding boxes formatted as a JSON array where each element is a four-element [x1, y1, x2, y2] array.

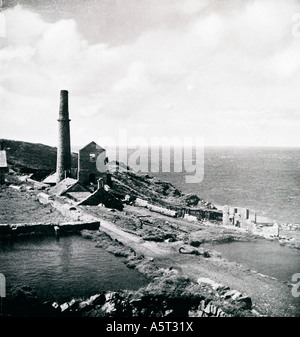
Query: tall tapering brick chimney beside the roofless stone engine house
[[56, 90, 71, 183]]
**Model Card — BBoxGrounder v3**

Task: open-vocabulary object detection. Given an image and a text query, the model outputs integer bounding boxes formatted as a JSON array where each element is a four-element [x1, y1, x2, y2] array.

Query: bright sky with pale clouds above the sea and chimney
[[0, 0, 300, 146]]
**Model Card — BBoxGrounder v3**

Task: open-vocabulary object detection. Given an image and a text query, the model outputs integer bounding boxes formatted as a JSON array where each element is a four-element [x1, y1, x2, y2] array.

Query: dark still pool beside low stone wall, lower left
[[0, 235, 148, 303]]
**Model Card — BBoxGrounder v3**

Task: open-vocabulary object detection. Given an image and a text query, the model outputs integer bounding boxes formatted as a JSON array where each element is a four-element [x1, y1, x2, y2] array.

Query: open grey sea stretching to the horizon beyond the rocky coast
[[134, 147, 300, 223]]
